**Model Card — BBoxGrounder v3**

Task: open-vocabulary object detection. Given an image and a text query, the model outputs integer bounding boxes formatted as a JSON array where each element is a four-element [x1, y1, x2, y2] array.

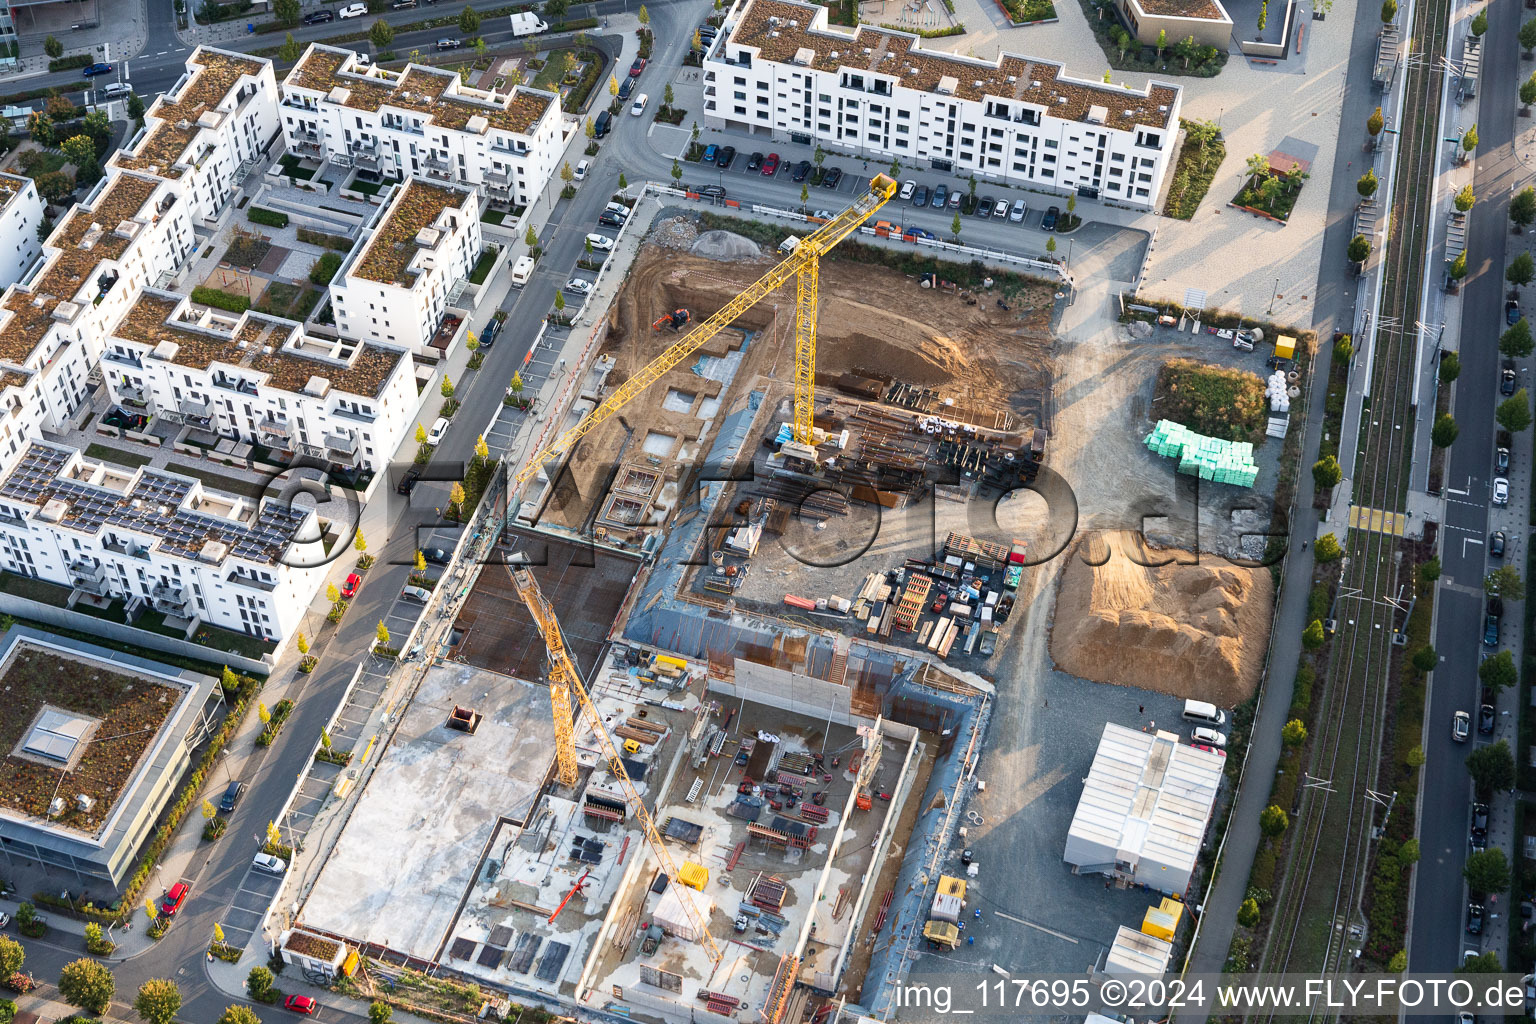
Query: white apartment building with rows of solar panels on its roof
[[0, 441, 327, 642]]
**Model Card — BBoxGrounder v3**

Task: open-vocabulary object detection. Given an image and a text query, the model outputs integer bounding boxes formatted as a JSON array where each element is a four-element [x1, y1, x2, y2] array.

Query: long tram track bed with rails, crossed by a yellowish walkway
[[1253, 0, 1450, 1019]]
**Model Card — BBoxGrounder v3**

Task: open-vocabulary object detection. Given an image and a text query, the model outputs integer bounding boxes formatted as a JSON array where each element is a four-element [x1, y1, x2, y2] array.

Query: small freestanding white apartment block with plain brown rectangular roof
[[330, 178, 481, 356]]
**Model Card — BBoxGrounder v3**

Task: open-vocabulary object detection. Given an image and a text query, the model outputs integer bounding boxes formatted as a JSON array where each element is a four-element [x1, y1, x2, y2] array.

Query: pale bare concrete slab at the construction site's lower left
[[300, 663, 553, 960]]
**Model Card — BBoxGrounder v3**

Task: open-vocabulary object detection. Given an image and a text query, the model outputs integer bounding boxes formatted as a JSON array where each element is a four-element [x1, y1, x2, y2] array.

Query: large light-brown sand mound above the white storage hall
[[1051, 533, 1275, 708]]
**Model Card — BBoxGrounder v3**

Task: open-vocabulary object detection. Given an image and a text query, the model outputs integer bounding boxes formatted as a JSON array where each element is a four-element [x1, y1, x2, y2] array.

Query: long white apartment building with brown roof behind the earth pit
[[703, 0, 1181, 209]]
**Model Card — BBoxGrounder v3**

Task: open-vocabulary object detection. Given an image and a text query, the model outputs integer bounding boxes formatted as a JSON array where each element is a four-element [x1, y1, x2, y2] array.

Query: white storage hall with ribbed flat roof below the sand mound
[[1063, 723, 1226, 895]]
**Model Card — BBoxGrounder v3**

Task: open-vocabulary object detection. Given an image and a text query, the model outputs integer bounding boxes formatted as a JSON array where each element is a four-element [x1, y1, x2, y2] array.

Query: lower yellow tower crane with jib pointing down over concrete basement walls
[[507, 565, 723, 964]]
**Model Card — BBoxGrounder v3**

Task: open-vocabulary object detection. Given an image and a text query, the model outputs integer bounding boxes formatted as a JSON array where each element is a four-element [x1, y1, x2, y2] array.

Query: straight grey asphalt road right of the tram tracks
[[1409, 3, 1528, 972]]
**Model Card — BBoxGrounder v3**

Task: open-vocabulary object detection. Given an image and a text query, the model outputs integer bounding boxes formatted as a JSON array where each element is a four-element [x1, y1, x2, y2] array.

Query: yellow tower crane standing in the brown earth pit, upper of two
[[516, 173, 897, 487]]
